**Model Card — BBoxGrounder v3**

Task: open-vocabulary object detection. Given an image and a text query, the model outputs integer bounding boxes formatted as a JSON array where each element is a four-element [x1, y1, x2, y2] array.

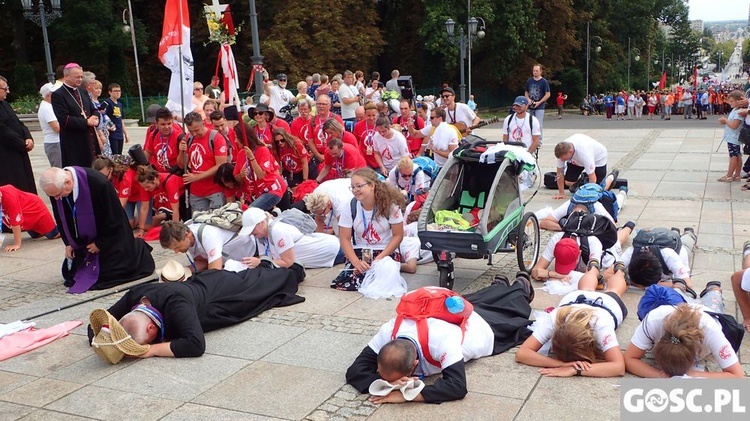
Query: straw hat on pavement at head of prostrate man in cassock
[[89, 308, 150, 364]]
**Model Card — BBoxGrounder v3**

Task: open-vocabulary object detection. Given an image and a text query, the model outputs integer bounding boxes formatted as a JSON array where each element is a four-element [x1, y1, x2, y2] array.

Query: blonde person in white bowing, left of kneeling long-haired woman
[[304, 178, 354, 235]]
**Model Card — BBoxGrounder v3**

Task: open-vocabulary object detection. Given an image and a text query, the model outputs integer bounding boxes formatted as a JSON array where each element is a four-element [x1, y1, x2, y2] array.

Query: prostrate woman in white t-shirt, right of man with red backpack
[[516, 262, 628, 377]]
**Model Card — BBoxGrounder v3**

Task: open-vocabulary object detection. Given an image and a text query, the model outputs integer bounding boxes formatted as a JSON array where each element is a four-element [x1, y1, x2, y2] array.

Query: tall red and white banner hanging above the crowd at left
[[159, 0, 194, 116]]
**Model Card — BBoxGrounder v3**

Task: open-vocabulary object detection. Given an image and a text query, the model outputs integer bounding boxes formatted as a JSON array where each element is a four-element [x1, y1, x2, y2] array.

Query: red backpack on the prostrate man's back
[[391, 287, 474, 367]]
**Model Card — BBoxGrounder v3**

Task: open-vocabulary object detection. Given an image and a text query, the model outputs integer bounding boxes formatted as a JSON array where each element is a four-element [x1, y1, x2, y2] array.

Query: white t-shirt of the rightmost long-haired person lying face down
[[630, 304, 739, 369]]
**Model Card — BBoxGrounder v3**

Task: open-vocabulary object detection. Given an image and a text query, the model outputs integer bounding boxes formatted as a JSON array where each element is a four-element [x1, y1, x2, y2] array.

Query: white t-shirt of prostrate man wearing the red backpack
[[367, 312, 495, 376]]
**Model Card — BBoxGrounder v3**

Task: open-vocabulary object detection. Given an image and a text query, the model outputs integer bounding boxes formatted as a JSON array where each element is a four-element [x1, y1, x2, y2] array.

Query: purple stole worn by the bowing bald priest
[[55, 167, 99, 294]]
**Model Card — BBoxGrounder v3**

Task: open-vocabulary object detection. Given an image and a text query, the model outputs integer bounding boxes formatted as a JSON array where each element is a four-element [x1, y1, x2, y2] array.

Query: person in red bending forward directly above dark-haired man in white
[[138, 165, 185, 226]]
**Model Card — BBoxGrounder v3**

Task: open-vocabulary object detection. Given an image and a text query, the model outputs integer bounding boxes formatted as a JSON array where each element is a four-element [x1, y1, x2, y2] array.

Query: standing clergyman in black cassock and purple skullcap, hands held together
[[52, 63, 101, 167]]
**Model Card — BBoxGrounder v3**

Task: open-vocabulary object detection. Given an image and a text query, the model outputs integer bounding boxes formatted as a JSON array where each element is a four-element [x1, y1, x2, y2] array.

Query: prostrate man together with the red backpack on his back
[[346, 274, 533, 404]]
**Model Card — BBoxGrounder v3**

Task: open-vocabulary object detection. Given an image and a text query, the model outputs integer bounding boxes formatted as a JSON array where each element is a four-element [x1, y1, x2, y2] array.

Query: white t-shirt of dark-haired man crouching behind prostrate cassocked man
[[188, 224, 255, 263]]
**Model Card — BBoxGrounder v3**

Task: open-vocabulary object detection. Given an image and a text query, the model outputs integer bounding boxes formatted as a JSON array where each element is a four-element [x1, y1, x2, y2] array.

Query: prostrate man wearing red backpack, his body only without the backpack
[[346, 274, 534, 404]]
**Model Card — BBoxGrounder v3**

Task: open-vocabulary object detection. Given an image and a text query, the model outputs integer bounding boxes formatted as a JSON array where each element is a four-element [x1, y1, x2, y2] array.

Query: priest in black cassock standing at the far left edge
[[0, 76, 36, 194]]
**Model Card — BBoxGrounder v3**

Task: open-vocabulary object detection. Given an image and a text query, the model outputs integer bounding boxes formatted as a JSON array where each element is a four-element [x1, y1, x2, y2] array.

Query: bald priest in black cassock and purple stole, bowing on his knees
[[39, 167, 154, 294]]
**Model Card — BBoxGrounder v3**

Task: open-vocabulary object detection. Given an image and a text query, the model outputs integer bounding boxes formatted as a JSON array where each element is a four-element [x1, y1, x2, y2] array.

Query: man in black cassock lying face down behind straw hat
[[88, 262, 305, 358]]
